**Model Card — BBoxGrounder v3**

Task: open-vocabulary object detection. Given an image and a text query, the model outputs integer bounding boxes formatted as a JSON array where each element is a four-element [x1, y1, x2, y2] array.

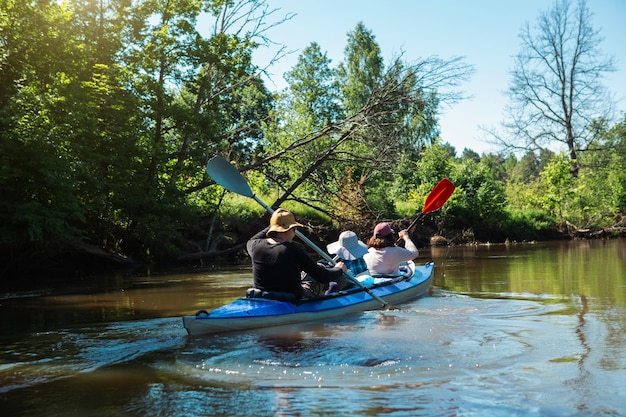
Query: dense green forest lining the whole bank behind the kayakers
[[0, 0, 626, 277]]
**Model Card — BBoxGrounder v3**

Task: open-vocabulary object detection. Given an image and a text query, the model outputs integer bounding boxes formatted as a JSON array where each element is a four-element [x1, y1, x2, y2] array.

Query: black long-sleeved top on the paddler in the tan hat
[[246, 228, 343, 298]]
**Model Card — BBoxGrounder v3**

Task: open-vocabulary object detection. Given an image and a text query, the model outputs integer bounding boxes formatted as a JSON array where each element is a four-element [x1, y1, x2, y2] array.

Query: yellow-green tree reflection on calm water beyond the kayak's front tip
[[430, 240, 626, 307]]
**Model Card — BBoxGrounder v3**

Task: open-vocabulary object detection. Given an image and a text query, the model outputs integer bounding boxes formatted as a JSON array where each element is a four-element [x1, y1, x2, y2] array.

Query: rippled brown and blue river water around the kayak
[[0, 240, 626, 417]]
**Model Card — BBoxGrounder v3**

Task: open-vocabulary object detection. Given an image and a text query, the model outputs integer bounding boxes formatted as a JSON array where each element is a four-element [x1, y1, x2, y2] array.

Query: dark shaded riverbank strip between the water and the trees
[[0, 222, 626, 286]]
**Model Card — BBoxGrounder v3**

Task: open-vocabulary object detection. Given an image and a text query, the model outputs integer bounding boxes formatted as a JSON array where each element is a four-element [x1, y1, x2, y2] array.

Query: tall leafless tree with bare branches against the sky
[[501, 0, 614, 176]]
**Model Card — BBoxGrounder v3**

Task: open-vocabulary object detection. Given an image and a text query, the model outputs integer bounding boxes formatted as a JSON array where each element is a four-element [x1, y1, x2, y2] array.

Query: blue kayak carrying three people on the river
[[183, 262, 434, 335]]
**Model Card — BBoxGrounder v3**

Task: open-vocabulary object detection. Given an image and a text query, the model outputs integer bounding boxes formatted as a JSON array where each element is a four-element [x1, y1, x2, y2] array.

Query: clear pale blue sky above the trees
[[254, 0, 626, 155]]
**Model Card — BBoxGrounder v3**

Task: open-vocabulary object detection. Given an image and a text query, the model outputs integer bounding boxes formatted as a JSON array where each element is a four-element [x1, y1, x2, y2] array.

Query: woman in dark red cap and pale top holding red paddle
[[363, 223, 419, 276]]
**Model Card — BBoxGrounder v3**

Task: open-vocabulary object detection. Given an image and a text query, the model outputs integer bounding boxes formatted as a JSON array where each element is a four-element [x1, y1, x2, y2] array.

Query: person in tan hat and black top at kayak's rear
[[246, 208, 346, 299]]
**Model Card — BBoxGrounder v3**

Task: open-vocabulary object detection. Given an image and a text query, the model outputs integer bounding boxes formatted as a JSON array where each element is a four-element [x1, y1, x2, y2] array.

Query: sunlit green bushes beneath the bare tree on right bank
[[498, 119, 626, 231]]
